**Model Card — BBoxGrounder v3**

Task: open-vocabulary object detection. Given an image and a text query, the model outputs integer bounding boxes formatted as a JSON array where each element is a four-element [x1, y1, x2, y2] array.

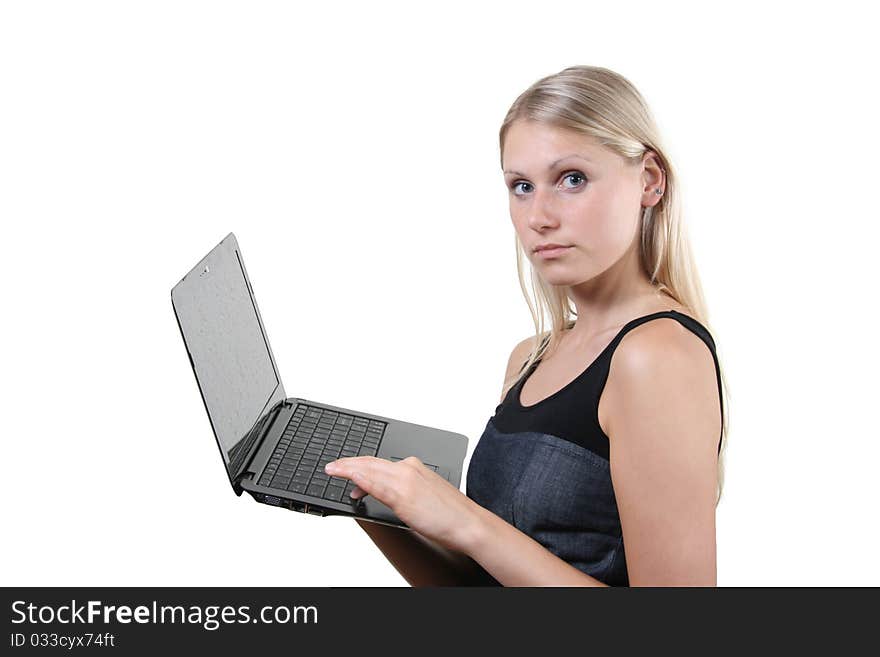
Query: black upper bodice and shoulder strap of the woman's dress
[[493, 310, 724, 459]]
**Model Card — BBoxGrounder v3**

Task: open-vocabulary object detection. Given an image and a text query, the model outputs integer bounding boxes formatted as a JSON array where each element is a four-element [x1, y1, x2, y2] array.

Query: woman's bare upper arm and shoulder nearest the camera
[[606, 317, 721, 586]]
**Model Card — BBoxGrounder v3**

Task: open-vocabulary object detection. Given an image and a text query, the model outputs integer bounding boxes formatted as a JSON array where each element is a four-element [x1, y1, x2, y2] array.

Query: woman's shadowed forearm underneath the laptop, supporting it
[[357, 519, 497, 587]]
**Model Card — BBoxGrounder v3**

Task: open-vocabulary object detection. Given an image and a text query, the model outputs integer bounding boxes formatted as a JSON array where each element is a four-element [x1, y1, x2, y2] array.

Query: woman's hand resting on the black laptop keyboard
[[324, 456, 480, 553]]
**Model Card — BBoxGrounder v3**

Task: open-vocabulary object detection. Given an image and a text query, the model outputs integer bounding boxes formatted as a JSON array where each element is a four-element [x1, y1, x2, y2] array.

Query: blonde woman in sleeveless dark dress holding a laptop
[[327, 66, 727, 586]]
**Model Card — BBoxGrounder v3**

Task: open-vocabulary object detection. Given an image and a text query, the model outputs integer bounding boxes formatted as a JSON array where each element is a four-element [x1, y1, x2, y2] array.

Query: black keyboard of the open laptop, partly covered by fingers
[[259, 404, 386, 502]]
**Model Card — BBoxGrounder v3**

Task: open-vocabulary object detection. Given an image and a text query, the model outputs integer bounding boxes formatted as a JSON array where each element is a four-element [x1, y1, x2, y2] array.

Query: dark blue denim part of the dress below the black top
[[466, 418, 629, 586]]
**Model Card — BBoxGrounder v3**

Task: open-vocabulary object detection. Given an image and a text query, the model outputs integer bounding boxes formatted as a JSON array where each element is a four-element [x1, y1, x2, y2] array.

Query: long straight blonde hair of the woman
[[499, 66, 729, 506]]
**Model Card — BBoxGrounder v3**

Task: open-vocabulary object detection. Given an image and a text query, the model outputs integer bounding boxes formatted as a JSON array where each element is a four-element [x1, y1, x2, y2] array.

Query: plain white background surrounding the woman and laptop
[[0, 0, 880, 586]]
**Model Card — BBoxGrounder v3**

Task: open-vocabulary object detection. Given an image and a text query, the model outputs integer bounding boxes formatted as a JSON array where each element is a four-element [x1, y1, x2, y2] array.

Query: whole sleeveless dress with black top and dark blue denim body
[[466, 311, 723, 586]]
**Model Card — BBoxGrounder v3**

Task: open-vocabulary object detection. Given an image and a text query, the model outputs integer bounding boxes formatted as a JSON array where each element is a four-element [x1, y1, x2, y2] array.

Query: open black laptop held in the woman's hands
[[171, 233, 468, 529]]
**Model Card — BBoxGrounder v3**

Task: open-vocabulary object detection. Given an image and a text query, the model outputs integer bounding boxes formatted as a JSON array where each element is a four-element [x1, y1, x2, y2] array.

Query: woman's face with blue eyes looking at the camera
[[502, 120, 645, 286]]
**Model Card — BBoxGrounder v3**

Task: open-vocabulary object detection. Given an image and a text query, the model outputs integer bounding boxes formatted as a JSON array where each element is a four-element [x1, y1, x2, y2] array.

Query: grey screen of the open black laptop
[[171, 233, 285, 477]]
